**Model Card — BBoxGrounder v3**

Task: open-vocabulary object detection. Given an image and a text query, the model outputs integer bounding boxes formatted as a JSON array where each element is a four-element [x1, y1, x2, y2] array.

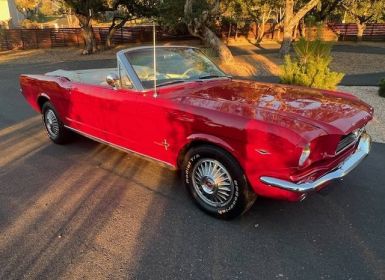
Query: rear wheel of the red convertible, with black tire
[[42, 101, 69, 144]]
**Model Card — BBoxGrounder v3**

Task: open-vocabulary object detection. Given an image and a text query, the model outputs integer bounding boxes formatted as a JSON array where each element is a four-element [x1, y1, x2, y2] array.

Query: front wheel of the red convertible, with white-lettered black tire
[[182, 146, 256, 219]]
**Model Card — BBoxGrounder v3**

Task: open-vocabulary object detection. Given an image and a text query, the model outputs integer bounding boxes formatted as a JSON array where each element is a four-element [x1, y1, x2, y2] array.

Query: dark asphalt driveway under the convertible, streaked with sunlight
[[0, 61, 385, 279]]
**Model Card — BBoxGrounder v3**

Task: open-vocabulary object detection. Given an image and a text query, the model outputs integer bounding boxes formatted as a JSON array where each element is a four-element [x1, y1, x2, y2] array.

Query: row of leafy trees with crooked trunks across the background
[[15, 0, 385, 56]]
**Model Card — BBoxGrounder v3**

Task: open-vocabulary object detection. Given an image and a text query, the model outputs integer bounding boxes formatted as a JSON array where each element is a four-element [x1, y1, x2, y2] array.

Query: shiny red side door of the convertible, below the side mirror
[[67, 80, 138, 147]]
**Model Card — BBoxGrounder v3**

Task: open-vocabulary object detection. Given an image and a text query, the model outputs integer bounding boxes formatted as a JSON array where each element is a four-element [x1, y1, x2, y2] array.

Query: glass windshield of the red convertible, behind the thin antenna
[[125, 47, 226, 89]]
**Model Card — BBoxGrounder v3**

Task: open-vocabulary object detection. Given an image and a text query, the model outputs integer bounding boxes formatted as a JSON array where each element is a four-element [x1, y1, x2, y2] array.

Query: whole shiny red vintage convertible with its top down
[[20, 46, 373, 219]]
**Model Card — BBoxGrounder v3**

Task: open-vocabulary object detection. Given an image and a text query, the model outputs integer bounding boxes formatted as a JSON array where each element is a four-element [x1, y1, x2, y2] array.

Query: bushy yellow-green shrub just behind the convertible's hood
[[280, 38, 344, 89]]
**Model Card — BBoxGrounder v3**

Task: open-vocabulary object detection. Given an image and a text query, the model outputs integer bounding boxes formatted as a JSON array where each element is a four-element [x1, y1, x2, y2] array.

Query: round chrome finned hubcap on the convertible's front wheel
[[192, 159, 234, 207]]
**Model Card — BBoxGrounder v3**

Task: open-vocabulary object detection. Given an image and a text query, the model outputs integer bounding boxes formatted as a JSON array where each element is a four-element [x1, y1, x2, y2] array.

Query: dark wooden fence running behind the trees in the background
[[0, 23, 385, 50]]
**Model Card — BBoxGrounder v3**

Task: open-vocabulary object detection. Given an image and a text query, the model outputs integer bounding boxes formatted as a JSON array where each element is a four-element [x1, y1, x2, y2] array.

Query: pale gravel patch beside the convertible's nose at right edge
[[338, 86, 385, 143]]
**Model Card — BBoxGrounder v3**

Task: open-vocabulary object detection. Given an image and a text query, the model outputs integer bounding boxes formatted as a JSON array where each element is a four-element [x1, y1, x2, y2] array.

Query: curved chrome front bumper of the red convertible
[[260, 132, 371, 193]]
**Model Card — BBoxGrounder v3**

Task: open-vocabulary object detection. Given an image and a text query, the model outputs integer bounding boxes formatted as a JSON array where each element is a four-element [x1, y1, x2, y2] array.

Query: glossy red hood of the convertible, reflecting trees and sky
[[164, 79, 373, 137]]
